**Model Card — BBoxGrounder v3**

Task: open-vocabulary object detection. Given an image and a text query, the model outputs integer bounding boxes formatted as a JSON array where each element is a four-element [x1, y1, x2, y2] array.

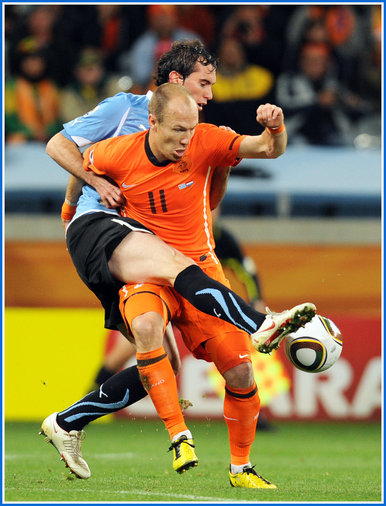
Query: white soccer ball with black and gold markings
[[285, 315, 343, 372]]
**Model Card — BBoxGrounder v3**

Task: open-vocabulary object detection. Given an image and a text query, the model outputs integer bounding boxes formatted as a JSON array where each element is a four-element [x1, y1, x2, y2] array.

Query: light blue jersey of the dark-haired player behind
[[61, 91, 152, 219]]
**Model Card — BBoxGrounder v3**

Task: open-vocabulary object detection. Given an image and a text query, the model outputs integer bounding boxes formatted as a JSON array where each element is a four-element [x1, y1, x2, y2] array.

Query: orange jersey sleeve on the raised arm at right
[[197, 123, 246, 166]]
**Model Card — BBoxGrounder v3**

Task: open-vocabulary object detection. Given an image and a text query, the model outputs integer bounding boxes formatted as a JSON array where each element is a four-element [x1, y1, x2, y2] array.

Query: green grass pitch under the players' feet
[[3, 420, 382, 503]]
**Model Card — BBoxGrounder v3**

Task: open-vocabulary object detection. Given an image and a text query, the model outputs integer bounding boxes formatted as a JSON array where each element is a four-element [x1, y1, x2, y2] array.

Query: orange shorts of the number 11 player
[[119, 261, 251, 373]]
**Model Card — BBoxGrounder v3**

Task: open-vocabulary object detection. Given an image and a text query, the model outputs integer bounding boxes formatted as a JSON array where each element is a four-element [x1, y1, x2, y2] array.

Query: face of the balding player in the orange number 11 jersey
[[149, 100, 198, 162]]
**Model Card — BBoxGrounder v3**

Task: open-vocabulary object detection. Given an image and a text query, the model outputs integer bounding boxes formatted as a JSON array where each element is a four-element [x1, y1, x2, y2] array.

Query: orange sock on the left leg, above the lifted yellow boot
[[137, 346, 187, 439]]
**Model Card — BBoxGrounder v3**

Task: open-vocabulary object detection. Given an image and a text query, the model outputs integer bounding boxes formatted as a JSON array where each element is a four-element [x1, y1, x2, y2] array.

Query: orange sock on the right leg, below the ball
[[224, 383, 260, 466]]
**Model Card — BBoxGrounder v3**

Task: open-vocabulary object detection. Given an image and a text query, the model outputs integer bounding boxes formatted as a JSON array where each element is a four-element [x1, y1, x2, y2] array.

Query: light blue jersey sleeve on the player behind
[[63, 93, 132, 147]]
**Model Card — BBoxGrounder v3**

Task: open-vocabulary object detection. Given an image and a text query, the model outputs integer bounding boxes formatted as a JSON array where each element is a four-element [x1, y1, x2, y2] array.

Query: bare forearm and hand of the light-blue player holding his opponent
[[46, 132, 123, 208]]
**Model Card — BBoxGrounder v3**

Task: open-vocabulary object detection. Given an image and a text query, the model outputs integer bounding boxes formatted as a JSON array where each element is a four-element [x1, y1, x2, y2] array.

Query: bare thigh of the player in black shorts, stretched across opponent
[[109, 232, 194, 286]]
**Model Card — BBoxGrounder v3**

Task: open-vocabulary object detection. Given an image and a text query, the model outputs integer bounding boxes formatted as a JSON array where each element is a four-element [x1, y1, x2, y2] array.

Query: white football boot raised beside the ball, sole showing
[[251, 302, 316, 353]]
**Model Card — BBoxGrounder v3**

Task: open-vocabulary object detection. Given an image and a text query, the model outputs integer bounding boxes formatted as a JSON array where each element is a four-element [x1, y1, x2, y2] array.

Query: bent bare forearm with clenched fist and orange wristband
[[238, 104, 287, 162]]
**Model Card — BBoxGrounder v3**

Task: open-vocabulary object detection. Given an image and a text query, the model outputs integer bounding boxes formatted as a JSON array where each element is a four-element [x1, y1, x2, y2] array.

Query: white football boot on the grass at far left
[[39, 413, 91, 480]]
